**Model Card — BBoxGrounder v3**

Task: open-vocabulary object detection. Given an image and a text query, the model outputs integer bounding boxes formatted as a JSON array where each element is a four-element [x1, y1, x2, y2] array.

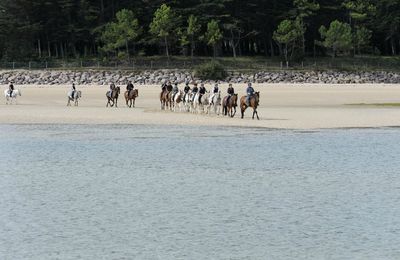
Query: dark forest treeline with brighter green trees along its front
[[0, 0, 400, 61]]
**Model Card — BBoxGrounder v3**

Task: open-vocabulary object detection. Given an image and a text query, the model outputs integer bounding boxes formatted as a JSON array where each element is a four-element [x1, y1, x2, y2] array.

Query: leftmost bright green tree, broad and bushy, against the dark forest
[[100, 9, 141, 58]]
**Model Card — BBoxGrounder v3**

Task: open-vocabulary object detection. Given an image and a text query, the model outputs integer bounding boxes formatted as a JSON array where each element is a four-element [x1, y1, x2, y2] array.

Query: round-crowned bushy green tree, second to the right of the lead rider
[[319, 20, 353, 57]]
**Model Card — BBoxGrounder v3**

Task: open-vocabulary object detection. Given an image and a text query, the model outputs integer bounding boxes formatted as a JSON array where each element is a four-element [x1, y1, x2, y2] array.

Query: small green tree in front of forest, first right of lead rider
[[273, 18, 305, 61]]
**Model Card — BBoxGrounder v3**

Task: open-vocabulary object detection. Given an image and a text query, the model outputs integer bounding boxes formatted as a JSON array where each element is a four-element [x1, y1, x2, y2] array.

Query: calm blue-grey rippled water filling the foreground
[[0, 125, 400, 260]]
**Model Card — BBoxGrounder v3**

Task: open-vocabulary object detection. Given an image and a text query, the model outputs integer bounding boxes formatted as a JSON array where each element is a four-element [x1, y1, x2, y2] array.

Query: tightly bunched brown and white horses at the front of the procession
[[160, 89, 260, 120]]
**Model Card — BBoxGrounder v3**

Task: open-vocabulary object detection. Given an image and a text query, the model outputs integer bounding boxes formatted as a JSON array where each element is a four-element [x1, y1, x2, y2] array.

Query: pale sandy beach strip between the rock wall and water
[[0, 84, 400, 130]]
